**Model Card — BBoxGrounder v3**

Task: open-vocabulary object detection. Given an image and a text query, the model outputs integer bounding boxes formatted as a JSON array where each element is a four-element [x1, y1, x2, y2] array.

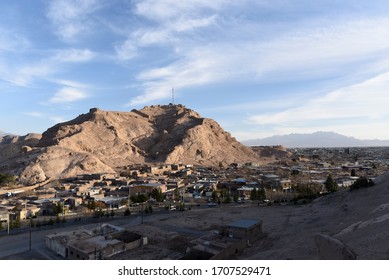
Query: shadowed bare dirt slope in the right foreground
[[108, 175, 389, 260]]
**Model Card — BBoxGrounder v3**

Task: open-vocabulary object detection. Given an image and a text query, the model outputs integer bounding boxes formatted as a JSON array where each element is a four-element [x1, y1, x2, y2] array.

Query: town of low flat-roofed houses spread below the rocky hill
[[0, 148, 389, 259]]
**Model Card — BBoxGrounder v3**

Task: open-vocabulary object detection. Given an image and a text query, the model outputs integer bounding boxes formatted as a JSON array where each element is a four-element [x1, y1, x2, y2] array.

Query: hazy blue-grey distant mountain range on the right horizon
[[242, 131, 389, 148]]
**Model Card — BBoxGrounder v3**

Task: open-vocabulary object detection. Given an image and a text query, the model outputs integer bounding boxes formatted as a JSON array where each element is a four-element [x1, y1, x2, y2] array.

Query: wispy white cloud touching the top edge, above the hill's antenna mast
[[115, 0, 226, 61]]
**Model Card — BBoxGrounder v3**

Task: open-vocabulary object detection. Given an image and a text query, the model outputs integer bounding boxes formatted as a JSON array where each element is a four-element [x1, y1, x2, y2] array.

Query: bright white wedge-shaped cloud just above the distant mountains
[[247, 72, 389, 136]]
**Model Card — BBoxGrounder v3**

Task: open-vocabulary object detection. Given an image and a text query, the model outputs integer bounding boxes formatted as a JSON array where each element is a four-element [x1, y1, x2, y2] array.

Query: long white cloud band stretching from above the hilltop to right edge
[[126, 18, 389, 105]]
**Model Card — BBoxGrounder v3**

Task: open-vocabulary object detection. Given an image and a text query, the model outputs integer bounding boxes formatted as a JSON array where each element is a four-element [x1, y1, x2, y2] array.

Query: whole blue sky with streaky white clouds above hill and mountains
[[0, 0, 389, 140]]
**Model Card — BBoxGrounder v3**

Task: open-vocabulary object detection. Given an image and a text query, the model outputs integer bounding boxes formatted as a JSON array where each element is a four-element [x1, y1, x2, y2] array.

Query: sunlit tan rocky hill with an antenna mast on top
[[0, 105, 260, 183]]
